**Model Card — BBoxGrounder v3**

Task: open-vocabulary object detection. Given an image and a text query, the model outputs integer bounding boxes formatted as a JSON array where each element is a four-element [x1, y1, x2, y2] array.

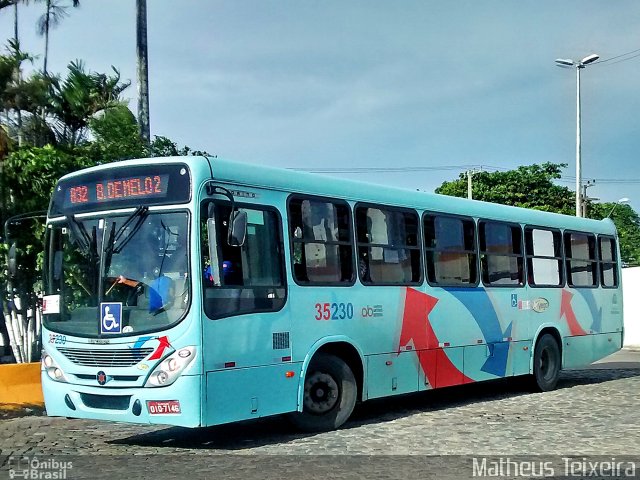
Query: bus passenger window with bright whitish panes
[[524, 227, 564, 287]]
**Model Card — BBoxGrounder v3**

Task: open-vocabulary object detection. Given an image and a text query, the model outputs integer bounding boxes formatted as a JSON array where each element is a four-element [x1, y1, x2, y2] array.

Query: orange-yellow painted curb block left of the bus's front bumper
[[0, 362, 44, 410]]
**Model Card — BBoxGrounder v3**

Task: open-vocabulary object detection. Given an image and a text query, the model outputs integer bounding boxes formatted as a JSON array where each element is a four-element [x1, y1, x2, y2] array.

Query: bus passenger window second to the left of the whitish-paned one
[[423, 215, 478, 286]]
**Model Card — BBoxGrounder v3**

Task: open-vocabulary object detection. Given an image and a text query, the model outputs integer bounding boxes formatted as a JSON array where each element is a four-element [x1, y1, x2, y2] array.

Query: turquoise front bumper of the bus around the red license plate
[[41, 371, 202, 427]]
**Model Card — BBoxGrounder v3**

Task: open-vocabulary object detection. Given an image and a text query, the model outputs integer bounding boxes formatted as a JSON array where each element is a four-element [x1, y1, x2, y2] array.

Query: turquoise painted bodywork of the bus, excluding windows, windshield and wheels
[[42, 158, 623, 426]]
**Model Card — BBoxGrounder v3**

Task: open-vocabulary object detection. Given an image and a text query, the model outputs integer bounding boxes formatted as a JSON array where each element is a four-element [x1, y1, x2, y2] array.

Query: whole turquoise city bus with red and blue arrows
[[42, 157, 623, 431]]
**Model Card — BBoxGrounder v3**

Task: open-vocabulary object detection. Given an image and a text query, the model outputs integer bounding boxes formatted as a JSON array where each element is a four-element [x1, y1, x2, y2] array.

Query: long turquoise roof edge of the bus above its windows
[[57, 156, 615, 235]]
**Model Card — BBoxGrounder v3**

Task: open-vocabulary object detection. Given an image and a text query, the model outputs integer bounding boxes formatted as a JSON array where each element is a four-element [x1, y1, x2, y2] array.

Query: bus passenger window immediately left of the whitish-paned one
[[478, 221, 524, 287]]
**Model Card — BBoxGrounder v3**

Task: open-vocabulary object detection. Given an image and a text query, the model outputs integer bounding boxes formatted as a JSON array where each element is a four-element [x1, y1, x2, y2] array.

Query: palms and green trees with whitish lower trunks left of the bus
[[0, 0, 205, 361]]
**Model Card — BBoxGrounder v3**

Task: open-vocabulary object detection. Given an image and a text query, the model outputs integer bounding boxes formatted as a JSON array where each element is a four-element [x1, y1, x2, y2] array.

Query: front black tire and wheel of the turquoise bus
[[289, 354, 358, 432]]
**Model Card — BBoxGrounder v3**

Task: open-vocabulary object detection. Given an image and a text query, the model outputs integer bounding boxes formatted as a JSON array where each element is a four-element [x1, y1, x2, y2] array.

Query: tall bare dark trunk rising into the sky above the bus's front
[[136, 0, 151, 145]]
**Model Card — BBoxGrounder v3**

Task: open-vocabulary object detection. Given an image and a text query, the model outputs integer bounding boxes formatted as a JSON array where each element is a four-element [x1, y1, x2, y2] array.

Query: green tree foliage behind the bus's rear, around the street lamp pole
[[436, 163, 640, 265]]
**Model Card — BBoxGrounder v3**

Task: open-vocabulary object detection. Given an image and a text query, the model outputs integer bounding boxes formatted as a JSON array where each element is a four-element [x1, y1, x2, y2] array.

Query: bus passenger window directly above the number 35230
[[289, 198, 354, 285]]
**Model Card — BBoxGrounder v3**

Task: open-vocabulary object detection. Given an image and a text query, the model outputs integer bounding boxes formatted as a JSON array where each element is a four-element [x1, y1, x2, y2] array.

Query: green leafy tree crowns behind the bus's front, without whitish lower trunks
[[0, 41, 206, 308]]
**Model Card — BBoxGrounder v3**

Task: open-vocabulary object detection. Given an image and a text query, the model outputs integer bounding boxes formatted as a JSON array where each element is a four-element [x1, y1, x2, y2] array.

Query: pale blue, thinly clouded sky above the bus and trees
[[0, 0, 640, 212]]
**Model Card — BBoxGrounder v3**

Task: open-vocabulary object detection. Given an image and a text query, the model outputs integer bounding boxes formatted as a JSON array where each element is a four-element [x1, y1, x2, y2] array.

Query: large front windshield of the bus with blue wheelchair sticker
[[43, 207, 190, 337]]
